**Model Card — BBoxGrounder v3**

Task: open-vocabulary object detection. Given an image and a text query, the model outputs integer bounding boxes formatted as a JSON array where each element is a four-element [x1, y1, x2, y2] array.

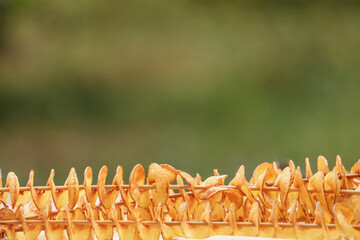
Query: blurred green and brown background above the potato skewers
[[0, 0, 360, 185]]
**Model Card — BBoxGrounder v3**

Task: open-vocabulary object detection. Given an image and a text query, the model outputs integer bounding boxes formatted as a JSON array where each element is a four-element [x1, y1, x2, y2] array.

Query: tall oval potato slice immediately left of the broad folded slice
[[129, 164, 150, 208]]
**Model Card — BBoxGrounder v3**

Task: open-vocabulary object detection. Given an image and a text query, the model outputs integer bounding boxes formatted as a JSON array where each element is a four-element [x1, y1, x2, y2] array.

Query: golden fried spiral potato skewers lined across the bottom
[[0, 156, 360, 239]]
